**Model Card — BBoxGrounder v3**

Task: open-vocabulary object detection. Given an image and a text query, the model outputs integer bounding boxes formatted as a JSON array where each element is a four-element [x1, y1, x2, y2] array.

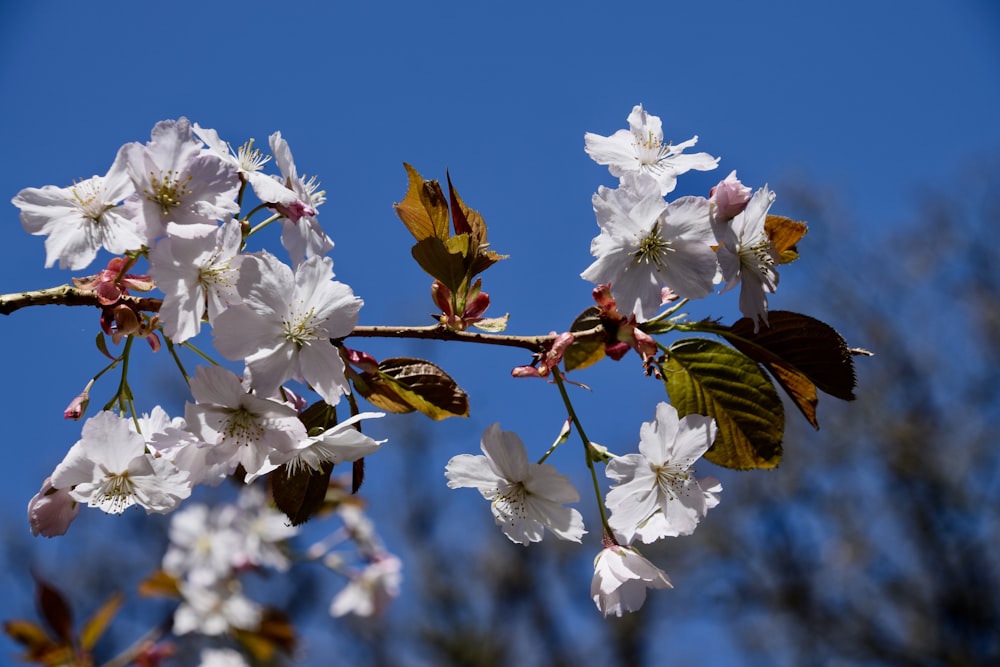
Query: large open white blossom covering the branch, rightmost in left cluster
[[213, 252, 364, 405]]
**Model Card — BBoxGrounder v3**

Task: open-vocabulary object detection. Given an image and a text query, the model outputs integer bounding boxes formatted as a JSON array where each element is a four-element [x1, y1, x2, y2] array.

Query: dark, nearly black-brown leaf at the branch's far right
[[722, 310, 857, 401]]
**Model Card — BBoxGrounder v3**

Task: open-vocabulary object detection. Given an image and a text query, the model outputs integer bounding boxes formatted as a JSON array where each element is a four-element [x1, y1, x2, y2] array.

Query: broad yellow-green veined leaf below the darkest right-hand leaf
[[663, 338, 785, 470]]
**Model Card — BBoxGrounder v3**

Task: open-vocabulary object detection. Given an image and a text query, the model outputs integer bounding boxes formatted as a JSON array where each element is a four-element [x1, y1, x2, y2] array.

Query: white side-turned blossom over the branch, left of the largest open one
[[149, 220, 243, 343]]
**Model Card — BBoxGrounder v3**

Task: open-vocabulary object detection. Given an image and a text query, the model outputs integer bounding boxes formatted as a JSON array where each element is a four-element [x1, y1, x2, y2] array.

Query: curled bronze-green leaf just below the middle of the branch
[[375, 357, 469, 420]]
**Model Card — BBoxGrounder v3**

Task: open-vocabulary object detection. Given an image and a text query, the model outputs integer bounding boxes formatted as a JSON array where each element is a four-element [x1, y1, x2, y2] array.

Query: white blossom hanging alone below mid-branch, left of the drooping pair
[[445, 424, 586, 545]]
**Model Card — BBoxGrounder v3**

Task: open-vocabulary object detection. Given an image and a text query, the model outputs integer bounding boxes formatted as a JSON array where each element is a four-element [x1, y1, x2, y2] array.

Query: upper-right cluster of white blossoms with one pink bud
[[581, 105, 779, 327]]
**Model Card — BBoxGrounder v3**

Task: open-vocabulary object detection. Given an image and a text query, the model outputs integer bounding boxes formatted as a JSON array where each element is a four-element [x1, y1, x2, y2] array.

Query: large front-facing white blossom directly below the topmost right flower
[[580, 174, 719, 320]]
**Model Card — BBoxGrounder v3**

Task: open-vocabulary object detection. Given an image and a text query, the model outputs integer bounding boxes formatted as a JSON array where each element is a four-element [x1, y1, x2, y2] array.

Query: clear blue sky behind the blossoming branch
[[0, 0, 1000, 664]]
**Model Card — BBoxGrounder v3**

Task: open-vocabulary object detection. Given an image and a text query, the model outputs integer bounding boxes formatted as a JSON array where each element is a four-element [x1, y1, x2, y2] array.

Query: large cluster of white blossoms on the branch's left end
[[13, 118, 381, 536]]
